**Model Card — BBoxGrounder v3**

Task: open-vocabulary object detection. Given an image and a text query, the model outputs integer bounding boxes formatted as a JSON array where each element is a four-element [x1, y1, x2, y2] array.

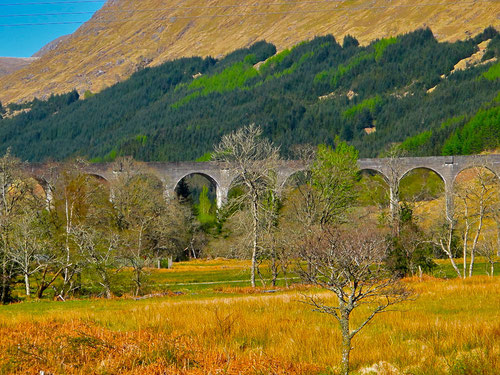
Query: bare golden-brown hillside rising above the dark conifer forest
[[0, 0, 500, 103]]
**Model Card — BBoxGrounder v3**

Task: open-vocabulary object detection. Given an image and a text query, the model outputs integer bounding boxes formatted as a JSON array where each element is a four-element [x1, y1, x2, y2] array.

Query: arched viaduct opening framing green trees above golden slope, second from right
[[399, 167, 447, 228]]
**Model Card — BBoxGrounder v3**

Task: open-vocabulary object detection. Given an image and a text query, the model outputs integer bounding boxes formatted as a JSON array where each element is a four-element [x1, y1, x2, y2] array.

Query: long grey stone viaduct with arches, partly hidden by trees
[[28, 154, 500, 214]]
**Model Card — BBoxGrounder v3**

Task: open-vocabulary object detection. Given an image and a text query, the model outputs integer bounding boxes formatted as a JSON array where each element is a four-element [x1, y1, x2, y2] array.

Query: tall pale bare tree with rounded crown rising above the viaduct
[[213, 124, 280, 286]]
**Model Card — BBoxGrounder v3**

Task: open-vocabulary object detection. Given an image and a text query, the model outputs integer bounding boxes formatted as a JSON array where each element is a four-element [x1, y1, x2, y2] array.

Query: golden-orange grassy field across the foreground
[[0, 260, 500, 375]]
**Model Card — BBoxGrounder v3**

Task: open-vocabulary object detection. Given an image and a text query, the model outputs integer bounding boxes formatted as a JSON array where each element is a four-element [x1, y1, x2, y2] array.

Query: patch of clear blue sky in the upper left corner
[[0, 0, 104, 57]]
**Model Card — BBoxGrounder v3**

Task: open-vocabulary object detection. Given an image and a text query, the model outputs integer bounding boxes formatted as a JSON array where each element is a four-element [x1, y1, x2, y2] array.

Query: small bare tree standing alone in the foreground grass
[[299, 226, 412, 375]]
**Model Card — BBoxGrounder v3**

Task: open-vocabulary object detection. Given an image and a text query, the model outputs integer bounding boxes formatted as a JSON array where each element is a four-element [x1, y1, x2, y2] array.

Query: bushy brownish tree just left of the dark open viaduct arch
[[111, 159, 188, 295]]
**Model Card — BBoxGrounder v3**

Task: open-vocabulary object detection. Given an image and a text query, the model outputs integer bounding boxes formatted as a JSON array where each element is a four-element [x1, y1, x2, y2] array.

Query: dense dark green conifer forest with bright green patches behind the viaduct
[[0, 27, 500, 161]]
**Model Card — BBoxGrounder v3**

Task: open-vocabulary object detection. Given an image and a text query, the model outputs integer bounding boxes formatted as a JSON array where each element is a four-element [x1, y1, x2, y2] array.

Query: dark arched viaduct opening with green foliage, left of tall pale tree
[[174, 173, 218, 227]]
